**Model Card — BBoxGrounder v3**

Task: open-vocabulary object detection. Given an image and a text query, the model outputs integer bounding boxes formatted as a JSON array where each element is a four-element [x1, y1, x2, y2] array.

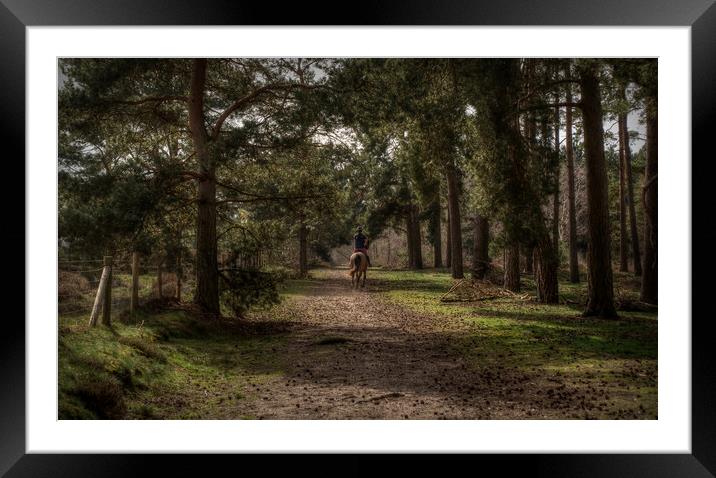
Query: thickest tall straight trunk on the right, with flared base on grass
[[580, 64, 617, 318]]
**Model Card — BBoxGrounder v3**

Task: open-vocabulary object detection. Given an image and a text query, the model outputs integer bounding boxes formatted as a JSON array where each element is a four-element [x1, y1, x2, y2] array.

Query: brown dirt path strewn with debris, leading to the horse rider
[[238, 271, 552, 419]]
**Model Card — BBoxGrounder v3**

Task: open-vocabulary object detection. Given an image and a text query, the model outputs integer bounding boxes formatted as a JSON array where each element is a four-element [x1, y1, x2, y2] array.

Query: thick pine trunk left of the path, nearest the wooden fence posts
[[189, 58, 219, 314]]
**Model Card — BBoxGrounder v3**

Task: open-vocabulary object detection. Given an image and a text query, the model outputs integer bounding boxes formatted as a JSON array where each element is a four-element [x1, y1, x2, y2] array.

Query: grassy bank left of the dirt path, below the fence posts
[[59, 310, 283, 419]]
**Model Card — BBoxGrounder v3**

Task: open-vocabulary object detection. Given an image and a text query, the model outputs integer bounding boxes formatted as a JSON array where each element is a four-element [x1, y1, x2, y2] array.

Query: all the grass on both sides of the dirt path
[[58, 269, 657, 419]]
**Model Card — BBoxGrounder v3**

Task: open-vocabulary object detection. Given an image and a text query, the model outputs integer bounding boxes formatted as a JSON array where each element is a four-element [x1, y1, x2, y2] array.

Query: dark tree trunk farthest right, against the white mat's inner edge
[[641, 98, 659, 304]]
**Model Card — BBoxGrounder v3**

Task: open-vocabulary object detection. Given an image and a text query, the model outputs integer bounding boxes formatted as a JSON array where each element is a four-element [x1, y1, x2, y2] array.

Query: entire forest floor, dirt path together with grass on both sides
[[60, 269, 657, 419]]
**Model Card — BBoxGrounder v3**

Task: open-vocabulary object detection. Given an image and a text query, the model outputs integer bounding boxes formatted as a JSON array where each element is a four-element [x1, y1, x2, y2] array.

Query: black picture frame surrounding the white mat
[[0, 0, 716, 477]]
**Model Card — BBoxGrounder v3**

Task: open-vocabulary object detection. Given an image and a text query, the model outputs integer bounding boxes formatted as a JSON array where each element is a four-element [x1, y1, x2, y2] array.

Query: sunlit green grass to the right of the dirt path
[[371, 270, 658, 418]]
